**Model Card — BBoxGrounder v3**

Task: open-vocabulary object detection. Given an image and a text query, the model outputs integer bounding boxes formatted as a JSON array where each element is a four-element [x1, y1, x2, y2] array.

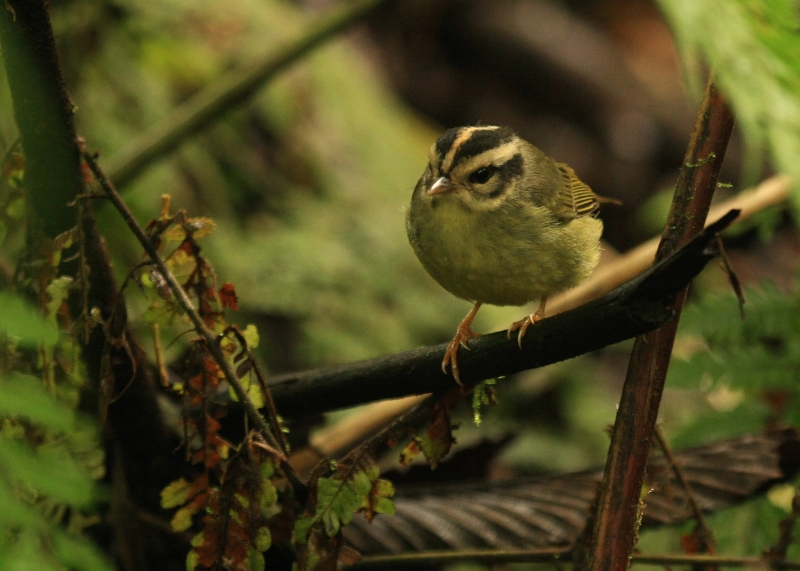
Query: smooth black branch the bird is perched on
[[271, 210, 738, 417]]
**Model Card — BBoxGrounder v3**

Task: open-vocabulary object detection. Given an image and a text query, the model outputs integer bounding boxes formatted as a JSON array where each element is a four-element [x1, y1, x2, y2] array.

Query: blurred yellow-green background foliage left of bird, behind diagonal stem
[[45, 0, 468, 366]]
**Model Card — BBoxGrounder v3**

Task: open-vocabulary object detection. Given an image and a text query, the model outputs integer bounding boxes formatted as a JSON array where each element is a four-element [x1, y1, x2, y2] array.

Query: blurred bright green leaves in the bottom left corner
[[0, 376, 110, 571]]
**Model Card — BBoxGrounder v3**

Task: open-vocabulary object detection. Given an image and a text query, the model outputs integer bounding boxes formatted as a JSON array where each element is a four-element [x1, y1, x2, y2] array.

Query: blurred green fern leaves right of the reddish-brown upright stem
[[667, 284, 800, 444]]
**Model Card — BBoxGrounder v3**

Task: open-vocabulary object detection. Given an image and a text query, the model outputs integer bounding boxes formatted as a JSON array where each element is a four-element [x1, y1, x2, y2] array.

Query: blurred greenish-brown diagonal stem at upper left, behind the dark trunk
[[105, 0, 396, 186]]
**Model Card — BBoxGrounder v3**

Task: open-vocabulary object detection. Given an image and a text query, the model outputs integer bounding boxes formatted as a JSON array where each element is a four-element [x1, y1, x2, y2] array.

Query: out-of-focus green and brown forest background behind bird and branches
[[0, 0, 800, 564]]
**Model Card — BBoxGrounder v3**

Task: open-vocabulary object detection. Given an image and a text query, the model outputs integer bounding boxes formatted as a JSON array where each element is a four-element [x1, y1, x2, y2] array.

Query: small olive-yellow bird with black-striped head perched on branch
[[406, 125, 619, 385]]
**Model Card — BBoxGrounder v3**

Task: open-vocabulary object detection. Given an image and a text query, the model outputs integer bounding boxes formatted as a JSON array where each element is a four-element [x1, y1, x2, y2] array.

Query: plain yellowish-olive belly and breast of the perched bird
[[408, 204, 603, 305]]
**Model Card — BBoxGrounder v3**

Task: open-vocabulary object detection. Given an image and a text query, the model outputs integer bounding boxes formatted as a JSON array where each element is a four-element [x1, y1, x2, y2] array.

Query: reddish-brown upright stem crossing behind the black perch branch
[[589, 74, 733, 570]]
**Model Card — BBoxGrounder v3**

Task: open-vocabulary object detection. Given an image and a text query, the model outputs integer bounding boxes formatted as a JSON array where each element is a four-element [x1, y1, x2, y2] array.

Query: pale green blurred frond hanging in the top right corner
[[659, 0, 800, 207]]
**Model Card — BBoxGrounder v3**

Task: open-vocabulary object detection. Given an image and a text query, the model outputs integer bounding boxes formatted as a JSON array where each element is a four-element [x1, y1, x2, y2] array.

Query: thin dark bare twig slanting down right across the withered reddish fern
[[84, 152, 306, 497]]
